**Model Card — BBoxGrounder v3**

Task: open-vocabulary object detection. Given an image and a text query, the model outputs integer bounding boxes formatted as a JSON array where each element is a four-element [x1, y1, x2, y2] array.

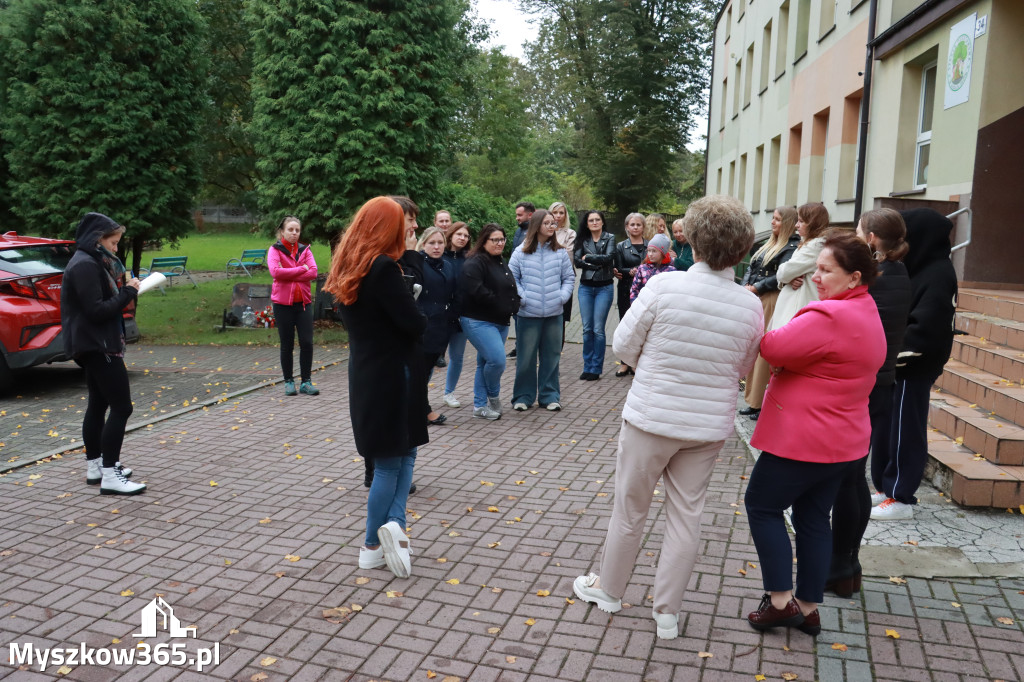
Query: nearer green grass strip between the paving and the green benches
[[136, 270, 348, 346]]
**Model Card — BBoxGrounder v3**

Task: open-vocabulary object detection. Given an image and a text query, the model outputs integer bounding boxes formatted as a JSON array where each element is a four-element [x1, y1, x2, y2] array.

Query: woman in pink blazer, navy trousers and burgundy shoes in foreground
[[745, 230, 886, 635]]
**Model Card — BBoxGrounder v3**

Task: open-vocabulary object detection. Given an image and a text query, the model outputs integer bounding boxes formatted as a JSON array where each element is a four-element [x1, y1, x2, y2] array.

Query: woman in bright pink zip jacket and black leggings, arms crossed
[[266, 215, 319, 395]]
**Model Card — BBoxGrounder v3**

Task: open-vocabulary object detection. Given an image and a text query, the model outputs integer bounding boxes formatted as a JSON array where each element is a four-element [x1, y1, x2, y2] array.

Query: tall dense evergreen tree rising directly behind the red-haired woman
[[249, 0, 471, 239]]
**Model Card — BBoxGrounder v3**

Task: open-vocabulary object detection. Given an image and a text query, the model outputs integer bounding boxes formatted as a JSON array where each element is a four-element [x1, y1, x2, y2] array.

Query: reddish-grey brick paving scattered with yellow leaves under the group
[[0, 337, 1024, 682]]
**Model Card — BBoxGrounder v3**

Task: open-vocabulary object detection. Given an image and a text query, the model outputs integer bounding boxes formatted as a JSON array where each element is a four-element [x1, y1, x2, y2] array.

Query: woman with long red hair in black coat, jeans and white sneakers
[[324, 197, 428, 578]]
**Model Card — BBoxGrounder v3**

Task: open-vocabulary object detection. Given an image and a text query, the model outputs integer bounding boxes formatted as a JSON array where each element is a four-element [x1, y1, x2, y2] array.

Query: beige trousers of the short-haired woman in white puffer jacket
[[599, 421, 725, 613]]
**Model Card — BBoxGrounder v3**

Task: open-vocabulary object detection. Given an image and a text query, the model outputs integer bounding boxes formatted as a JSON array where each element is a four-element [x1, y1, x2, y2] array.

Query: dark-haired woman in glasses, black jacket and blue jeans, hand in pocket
[[459, 222, 519, 420]]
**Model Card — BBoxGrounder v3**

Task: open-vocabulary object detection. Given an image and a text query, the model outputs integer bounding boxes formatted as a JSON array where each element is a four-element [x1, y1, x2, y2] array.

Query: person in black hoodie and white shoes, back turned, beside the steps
[[871, 209, 956, 520]]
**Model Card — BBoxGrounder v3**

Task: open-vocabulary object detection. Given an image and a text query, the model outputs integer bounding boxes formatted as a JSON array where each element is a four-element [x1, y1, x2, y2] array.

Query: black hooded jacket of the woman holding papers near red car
[[60, 213, 138, 357]]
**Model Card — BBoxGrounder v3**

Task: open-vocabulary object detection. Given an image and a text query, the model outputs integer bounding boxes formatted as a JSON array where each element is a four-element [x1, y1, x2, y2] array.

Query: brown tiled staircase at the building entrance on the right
[[925, 289, 1024, 503]]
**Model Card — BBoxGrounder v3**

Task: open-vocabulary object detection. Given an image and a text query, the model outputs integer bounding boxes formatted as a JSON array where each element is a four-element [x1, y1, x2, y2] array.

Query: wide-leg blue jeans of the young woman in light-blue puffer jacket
[[512, 313, 562, 407]]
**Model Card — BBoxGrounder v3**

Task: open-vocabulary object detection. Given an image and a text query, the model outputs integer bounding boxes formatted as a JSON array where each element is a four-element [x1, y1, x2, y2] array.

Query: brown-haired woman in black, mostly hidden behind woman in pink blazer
[[825, 209, 910, 598]]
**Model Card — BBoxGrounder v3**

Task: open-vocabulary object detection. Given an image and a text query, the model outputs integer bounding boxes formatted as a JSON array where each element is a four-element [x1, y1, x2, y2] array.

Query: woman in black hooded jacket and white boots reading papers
[[60, 213, 145, 495]]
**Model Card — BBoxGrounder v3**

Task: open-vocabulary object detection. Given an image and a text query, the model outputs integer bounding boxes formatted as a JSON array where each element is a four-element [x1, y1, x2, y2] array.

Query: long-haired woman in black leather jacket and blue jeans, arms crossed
[[573, 211, 615, 381]]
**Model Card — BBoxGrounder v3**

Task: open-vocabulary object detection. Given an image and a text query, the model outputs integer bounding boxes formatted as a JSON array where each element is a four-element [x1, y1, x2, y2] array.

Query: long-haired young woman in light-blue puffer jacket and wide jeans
[[509, 210, 575, 412]]
